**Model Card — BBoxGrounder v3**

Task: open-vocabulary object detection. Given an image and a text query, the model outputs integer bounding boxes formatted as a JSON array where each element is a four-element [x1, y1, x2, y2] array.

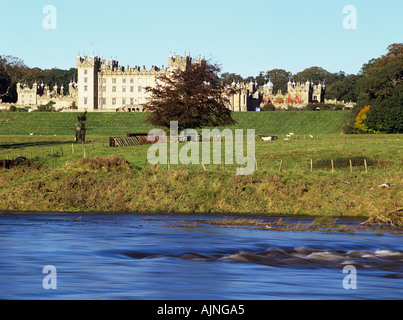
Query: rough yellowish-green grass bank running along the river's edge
[[0, 156, 403, 226]]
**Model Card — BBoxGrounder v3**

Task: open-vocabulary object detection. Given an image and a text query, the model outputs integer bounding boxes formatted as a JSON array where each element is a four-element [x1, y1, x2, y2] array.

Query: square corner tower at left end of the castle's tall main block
[[77, 56, 101, 111]]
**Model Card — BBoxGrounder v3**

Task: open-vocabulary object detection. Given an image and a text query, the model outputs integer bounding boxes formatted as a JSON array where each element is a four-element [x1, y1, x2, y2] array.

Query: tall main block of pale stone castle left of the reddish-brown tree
[[77, 55, 200, 112]]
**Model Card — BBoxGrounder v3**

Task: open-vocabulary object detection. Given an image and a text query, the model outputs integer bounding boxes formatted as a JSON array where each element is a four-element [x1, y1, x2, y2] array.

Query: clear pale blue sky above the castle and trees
[[0, 0, 403, 77]]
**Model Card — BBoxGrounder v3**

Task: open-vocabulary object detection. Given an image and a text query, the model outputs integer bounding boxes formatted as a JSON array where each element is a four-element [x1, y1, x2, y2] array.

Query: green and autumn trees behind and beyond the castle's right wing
[[221, 43, 403, 133]]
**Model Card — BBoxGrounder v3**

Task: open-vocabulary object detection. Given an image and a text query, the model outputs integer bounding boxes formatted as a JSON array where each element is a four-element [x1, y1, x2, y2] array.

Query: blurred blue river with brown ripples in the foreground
[[0, 213, 403, 300]]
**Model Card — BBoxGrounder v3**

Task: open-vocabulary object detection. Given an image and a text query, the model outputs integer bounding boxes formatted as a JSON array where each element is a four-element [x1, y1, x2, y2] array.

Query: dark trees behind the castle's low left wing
[[0, 55, 77, 103]]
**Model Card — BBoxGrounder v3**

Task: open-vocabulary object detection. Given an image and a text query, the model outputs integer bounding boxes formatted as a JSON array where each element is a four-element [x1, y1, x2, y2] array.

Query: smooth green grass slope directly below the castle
[[0, 111, 351, 136]]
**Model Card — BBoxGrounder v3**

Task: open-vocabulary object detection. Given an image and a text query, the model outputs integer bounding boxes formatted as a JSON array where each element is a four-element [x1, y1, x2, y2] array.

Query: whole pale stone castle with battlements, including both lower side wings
[[11, 55, 325, 112]]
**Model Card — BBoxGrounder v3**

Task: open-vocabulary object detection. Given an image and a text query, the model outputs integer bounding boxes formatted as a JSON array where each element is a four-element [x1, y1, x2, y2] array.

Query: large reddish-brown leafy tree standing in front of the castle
[[146, 60, 235, 131]]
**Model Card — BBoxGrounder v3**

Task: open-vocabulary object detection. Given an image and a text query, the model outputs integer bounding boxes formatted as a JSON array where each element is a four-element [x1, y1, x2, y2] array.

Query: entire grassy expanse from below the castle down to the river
[[0, 112, 403, 224]]
